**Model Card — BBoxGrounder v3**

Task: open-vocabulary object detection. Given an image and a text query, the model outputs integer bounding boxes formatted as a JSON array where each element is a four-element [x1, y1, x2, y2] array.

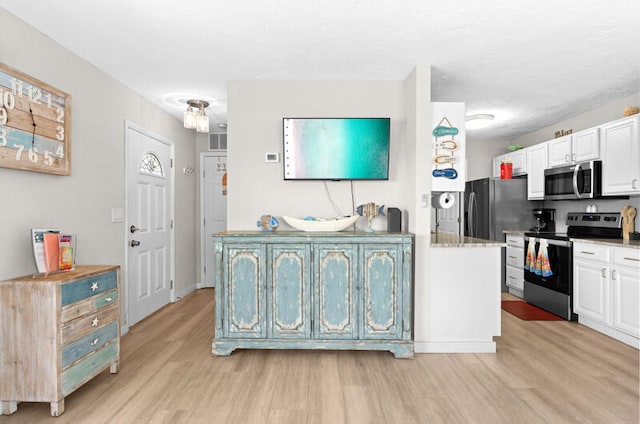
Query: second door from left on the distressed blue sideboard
[[269, 245, 311, 338]]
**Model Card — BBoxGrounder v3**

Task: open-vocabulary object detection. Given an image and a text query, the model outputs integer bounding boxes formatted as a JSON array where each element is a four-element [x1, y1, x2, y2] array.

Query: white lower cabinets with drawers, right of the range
[[573, 242, 640, 348]]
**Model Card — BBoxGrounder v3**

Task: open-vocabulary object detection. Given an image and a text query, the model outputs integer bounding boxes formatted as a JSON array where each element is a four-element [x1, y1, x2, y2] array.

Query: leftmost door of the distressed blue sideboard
[[224, 246, 266, 338]]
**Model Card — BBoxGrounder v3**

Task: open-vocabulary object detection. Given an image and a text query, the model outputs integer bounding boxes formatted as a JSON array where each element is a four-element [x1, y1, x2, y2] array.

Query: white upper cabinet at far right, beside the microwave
[[600, 115, 640, 195]]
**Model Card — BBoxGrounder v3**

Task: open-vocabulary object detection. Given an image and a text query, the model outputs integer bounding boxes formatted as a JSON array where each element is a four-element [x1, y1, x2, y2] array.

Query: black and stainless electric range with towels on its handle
[[524, 212, 622, 320]]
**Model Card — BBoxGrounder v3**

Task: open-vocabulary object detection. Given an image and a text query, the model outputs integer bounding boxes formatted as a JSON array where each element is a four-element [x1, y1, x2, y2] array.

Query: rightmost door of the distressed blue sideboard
[[362, 245, 402, 339]]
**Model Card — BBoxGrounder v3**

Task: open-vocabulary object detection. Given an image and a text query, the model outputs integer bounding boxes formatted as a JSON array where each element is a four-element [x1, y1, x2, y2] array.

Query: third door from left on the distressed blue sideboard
[[314, 245, 358, 339]]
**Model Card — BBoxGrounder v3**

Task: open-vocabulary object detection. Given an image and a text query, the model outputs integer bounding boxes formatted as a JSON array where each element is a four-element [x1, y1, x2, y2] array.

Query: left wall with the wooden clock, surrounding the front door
[[0, 8, 196, 322]]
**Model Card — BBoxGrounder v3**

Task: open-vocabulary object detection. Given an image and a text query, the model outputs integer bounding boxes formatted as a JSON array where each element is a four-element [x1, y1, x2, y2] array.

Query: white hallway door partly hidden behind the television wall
[[200, 153, 227, 287]]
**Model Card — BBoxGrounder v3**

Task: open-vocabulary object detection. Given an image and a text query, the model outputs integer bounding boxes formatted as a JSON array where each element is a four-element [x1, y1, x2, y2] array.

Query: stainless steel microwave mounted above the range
[[544, 160, 602, 200]]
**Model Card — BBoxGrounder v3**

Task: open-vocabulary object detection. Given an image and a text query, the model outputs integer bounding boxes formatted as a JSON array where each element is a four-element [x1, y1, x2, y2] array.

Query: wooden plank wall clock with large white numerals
[[0, 63, 71, 175]]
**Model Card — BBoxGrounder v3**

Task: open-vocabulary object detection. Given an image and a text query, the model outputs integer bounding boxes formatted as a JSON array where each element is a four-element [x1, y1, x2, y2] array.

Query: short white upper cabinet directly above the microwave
[[549, 127, 600, 168]]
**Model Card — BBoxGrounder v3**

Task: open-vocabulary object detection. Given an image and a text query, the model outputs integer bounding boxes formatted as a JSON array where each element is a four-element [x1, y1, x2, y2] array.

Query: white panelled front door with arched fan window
[[126, 124, 174, 326]]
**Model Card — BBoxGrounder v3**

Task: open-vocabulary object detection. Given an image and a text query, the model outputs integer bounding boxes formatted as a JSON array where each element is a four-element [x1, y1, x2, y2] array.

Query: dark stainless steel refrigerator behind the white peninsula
[[464, 177, 542, 291]]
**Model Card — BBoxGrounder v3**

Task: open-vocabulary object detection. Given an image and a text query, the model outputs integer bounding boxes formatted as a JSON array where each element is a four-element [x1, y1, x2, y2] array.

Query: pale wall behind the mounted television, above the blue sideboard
[[227, 81, 407, 230]]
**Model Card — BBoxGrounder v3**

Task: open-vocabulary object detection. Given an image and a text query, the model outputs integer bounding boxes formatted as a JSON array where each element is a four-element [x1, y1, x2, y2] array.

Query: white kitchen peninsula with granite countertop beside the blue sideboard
[[415, 233, 506, 353]]
